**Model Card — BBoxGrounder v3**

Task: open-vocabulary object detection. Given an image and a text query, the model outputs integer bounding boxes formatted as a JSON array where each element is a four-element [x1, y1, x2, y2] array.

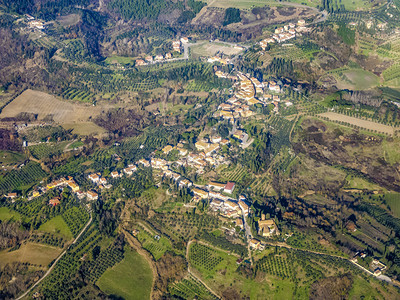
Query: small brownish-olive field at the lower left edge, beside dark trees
[[0, 242, 62, 267]]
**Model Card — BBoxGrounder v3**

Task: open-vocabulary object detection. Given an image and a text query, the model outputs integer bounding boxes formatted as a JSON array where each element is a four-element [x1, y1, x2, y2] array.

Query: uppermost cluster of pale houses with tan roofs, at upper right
[[260, 19, 311, 50]]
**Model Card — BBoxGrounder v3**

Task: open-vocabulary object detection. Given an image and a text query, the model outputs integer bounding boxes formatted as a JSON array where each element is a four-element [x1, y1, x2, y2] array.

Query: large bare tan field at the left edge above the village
[[0, 90, 106, 124]]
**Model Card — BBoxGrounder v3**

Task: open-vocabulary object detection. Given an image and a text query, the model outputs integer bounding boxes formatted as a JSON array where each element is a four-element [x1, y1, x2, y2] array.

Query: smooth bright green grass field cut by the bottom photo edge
[[97, 249, 153, 300]]
